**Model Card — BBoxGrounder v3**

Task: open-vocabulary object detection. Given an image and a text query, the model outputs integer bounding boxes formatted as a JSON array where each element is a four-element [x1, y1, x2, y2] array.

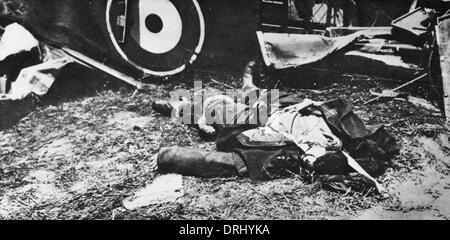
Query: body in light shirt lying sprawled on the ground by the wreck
[[153, 62, 397, 195]]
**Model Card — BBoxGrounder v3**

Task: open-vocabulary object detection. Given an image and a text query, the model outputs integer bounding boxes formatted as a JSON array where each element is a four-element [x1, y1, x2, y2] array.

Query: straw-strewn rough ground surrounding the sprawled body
[[0, 66, 450, 219]]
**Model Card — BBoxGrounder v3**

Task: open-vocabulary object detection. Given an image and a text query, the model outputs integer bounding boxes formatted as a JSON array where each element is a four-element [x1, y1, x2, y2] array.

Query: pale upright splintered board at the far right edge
[[436, 14, 450, 123]]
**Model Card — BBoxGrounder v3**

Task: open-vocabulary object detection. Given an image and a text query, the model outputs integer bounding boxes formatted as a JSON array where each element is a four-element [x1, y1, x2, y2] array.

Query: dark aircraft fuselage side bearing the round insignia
[[0, 0, 259, 78]]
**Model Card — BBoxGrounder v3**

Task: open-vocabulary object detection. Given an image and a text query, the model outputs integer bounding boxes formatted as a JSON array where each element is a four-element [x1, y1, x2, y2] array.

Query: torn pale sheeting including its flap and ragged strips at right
[[257, 27, 421, 69]]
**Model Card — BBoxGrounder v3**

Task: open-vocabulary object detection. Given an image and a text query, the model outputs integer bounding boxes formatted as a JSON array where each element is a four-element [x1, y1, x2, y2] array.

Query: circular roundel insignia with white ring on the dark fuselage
[[106, 0, 205, 76]]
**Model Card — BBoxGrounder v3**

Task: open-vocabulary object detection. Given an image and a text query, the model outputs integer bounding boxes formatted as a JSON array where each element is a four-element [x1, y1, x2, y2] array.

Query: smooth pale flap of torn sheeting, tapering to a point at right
[[257, 31, 364, 69]]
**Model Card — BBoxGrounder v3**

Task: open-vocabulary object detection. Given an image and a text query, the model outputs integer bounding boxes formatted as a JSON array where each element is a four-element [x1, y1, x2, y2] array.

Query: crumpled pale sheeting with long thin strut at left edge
[[0, 23, 154, 100]]
